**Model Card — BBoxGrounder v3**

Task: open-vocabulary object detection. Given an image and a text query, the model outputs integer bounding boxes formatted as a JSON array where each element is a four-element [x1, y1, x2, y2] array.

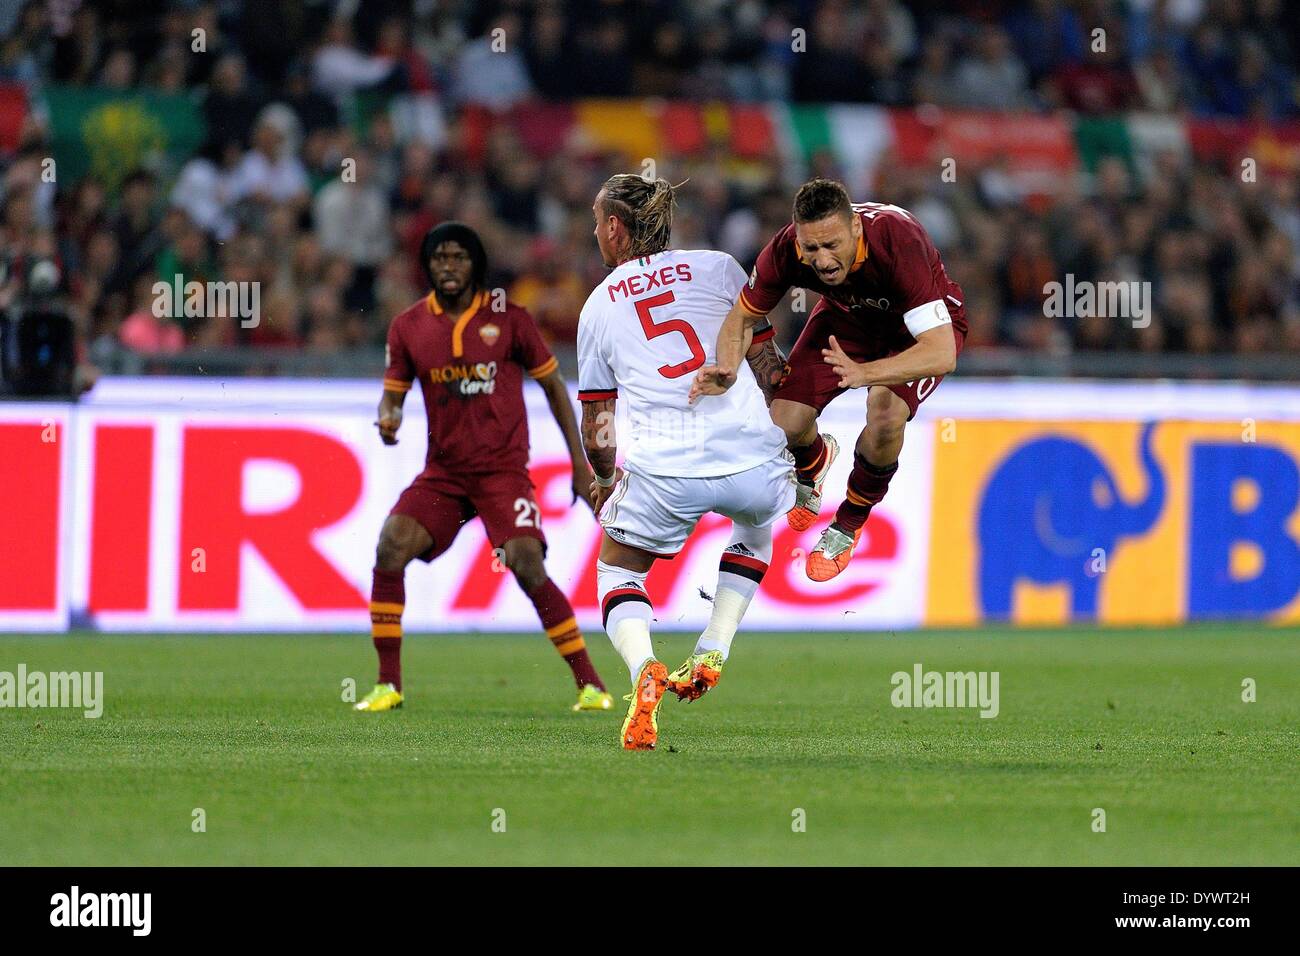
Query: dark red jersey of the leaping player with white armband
[[740, 203, 966, 346]]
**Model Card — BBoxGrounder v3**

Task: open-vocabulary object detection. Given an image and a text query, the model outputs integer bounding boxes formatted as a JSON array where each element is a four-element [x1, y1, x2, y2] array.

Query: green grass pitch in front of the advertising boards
[[0, 626, 1300, 866]]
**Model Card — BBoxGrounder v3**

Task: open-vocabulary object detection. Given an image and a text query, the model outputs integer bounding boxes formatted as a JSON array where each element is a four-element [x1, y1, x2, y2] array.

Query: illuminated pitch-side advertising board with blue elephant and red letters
[[0, 378, 1300, 633]]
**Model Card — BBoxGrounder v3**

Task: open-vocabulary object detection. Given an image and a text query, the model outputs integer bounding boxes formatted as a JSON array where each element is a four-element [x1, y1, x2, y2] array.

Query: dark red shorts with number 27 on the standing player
[[389, 470, 546, 561]]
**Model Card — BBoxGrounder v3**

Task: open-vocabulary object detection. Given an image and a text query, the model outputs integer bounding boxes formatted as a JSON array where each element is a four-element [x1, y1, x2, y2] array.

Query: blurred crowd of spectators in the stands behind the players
[[0, 0, 1300, 382]]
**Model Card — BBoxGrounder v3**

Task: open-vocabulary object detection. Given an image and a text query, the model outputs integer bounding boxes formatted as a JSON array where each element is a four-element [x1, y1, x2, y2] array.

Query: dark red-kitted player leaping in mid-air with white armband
[[692, 179, 966, 581]]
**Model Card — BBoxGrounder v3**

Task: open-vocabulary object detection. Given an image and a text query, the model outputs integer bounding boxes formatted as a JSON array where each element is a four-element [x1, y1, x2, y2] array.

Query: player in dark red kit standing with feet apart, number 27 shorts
[[356, 222, 612, 713]]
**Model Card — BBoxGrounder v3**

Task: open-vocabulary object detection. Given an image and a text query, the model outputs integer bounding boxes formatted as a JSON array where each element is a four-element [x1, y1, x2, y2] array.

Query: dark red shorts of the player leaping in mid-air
[[774, 299, 966, 421]]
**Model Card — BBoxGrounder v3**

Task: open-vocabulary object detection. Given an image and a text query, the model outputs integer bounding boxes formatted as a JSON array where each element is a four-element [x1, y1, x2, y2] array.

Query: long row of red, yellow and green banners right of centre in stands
[[464, 100, 1300, 188]]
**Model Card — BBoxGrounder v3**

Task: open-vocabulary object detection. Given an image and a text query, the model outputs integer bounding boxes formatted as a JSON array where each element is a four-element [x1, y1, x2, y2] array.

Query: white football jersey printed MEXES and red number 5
[[577, 250, 785, 477]]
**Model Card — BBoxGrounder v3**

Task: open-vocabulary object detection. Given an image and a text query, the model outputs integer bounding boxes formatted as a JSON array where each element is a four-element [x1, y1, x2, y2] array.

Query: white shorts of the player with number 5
[[601, 455, 794, 558]]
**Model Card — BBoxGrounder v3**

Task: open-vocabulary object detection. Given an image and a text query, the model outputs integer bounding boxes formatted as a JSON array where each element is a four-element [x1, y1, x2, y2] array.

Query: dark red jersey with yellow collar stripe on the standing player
[[384, 291, 559, 473]]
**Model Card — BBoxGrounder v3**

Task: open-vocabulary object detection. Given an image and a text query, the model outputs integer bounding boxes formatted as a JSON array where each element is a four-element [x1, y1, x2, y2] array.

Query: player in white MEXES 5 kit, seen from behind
[[577, 173, 796, 750]]
